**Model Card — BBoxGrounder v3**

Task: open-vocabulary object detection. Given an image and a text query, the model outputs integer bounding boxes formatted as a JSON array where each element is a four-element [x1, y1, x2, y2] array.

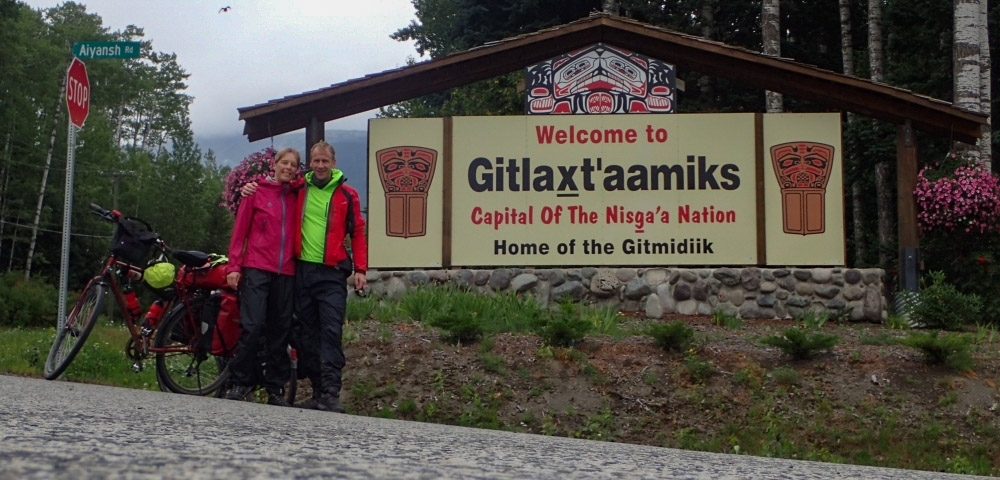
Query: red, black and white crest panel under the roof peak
[[525, 43, 677, 115]]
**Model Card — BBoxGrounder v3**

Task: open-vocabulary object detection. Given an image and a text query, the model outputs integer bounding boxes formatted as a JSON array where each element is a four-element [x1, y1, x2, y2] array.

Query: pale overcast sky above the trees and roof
[[23, 0, 423, 137]]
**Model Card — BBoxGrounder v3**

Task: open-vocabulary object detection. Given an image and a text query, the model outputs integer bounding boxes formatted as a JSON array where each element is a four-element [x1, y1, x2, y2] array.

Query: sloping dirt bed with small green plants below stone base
[[332, 306, 1000, 475]]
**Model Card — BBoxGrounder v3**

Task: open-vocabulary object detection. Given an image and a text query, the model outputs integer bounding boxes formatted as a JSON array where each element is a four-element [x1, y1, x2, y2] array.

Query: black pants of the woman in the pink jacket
[[229, 268, 295, 392]]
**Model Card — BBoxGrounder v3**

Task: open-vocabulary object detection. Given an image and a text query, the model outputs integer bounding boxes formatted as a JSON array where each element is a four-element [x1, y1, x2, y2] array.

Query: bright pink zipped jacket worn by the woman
[[226, 179, 299, 275]]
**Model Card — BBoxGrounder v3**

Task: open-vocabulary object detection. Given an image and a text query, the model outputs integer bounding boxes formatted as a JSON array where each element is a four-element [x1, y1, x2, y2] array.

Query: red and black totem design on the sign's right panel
[[771, 142, 834, 235]]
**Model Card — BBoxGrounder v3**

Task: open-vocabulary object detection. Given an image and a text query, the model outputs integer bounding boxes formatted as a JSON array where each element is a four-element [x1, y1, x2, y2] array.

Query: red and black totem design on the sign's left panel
[[375, 146, 437, 238]]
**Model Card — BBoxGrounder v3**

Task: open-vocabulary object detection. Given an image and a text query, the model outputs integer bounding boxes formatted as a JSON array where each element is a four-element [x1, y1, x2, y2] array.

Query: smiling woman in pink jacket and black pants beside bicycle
[[226, 148, 301, 407]]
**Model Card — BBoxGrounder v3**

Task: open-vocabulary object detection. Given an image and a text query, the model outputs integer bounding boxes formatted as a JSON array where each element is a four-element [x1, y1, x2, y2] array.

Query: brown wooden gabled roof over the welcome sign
[[238, 14, 987, 143]]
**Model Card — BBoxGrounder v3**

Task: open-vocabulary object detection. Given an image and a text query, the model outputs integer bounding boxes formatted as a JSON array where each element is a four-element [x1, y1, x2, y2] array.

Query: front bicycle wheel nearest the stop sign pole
[[44, 277, 104, 380]]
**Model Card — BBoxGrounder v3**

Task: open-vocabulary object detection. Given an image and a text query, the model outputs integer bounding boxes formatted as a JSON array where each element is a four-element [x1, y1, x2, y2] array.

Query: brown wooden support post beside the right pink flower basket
[[896, 120, 920, 291]]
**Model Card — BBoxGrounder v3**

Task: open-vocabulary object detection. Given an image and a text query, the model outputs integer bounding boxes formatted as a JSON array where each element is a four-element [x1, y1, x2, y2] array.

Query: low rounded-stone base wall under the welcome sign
[[358, 267, 887, 322]]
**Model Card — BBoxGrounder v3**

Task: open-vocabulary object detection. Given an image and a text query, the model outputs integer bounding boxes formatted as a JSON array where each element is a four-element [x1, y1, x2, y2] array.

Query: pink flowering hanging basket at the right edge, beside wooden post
[[913, 154, 1000, 233]]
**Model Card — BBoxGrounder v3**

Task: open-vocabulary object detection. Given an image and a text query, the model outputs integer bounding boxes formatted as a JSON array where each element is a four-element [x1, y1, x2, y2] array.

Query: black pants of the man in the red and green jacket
[[293, 261, 348, 396]]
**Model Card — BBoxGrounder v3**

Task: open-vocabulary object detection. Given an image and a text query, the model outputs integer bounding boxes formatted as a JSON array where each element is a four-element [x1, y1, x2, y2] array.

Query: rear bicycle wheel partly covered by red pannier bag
[[153, 297, 229, 395]]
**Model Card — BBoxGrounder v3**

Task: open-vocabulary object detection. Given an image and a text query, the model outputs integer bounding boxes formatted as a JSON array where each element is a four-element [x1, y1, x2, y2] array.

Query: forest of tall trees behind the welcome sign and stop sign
[[0, 0, 1000, 317]]
